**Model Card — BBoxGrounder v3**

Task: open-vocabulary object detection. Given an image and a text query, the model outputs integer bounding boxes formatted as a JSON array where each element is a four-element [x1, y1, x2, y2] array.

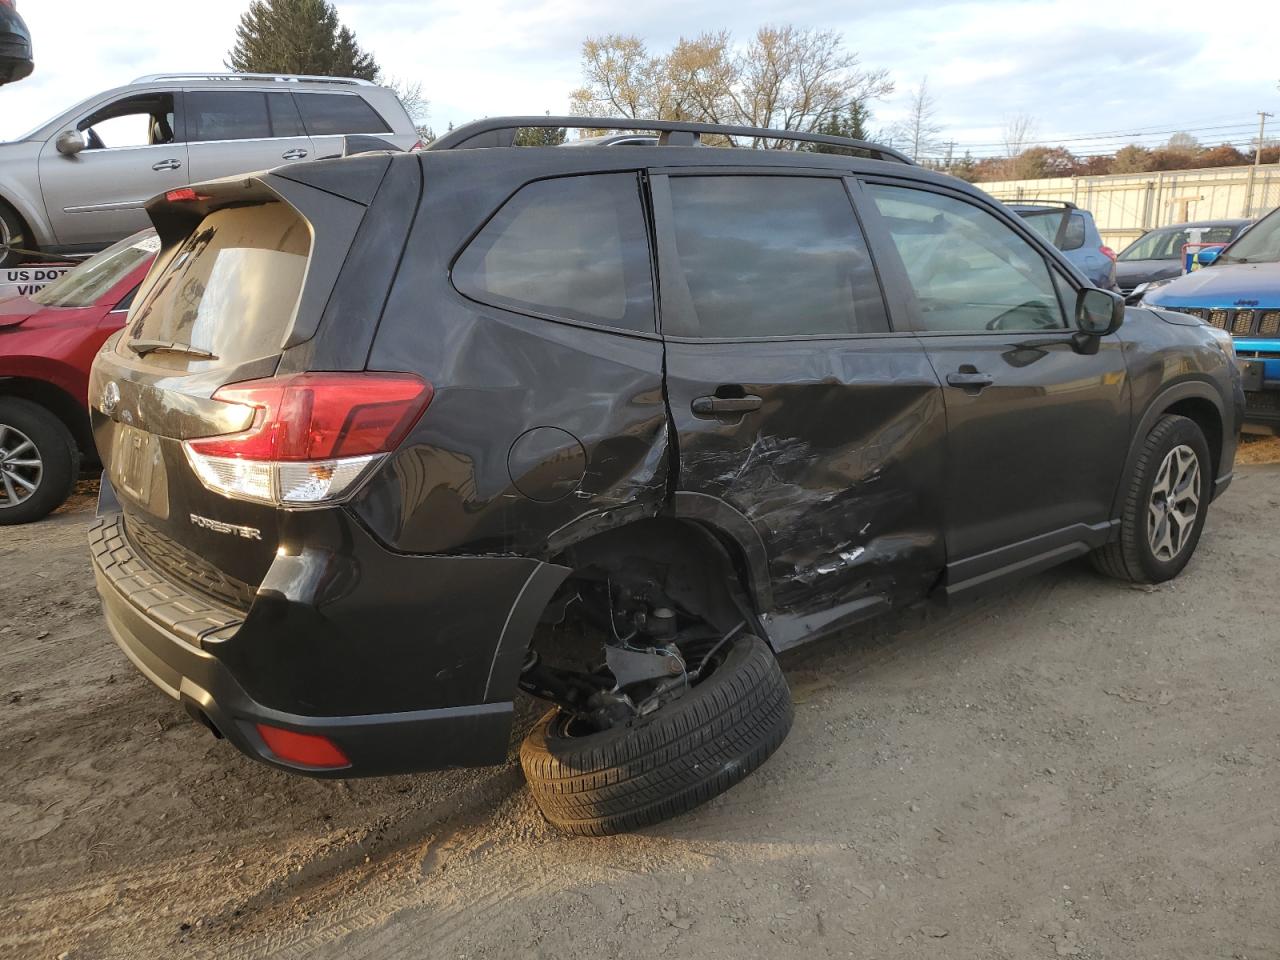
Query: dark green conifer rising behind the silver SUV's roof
[[227, 0, 379, 81]]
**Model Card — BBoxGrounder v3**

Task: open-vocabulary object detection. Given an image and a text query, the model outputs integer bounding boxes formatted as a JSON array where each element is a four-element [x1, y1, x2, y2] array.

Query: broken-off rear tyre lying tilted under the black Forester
[[520, 636, 794, 836]]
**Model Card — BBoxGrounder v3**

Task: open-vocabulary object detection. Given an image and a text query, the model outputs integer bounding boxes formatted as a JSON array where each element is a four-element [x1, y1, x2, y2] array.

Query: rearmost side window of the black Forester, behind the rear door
[[453, 173, 654, 333]]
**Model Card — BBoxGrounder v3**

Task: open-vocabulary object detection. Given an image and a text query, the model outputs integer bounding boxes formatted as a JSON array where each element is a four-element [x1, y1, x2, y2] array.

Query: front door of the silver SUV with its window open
[[40, 91, 189, 248]]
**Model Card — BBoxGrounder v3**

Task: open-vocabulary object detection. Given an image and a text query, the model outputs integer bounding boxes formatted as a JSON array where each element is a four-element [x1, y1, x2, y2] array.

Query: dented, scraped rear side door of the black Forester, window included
[[652, 170, 945, 646]]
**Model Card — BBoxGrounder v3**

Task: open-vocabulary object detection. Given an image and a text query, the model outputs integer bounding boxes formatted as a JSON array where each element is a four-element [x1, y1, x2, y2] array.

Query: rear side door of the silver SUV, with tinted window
[[184, 90, 312, 183]]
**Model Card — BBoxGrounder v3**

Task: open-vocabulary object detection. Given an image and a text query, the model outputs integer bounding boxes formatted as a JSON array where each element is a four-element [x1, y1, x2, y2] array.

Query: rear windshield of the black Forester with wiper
[[120, 202, 311, 369]]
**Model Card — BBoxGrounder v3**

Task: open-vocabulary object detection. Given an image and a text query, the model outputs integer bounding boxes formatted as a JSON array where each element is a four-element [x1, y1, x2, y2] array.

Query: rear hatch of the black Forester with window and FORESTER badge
[[88, 157, 421, 609]]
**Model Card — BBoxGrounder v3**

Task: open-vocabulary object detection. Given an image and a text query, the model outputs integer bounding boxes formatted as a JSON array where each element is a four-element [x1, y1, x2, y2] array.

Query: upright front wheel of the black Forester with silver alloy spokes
[[1092, 415, 1213, 584]]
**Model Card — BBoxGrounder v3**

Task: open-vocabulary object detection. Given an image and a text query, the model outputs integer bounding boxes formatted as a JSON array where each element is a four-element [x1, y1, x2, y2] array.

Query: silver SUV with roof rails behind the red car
[[0, 73, 417, 266]]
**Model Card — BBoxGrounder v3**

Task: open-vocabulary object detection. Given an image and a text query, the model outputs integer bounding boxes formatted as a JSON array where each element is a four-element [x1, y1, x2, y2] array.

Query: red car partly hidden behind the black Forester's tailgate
[[0, 230, 160, 525]]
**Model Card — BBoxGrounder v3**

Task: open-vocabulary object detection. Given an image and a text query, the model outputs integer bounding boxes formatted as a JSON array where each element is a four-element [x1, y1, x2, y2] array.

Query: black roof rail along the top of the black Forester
[[428, 116, 913, 164]]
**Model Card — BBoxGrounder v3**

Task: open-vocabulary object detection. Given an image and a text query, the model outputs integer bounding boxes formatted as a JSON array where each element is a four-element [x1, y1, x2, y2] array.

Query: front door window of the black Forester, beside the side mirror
[[867, 184, 1066, 333]]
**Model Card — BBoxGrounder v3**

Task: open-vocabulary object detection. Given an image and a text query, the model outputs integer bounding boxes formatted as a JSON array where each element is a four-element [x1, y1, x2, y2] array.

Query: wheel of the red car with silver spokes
[[0, 397, 79, 525]]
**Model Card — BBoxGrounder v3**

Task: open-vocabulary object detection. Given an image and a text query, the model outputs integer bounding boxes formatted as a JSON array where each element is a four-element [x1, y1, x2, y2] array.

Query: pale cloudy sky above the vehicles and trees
[[0, 0, 1280, 156]]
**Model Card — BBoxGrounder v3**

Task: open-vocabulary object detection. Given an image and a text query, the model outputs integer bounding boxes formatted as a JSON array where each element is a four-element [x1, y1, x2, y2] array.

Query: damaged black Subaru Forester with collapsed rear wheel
[[90, 118, 1243, 833]]
